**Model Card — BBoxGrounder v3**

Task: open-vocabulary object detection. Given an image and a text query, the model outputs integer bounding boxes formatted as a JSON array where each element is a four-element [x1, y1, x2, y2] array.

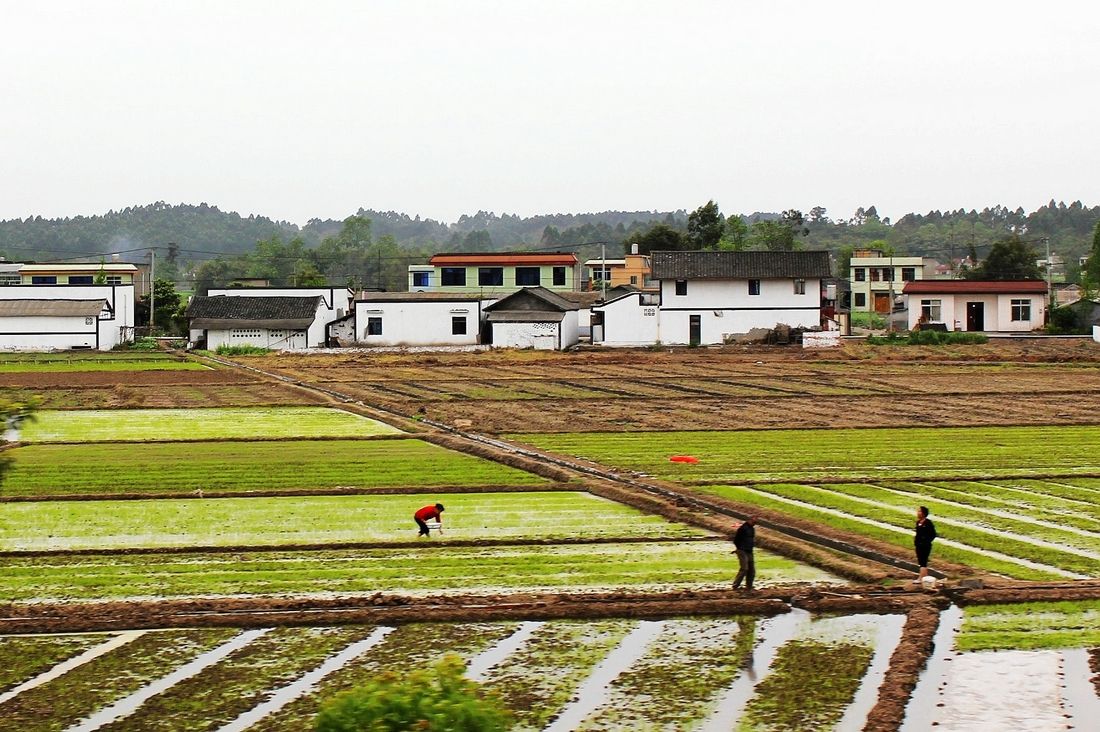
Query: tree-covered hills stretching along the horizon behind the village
[[0, 199, 1100, 289]]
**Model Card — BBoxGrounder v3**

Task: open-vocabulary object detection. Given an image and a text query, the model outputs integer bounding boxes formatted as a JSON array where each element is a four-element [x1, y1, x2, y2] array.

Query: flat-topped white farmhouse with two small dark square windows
[[354, 292, 493, 346]]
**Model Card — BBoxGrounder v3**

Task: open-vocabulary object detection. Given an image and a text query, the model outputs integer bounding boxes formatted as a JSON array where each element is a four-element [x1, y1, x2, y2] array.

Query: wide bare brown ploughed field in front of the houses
[[245, 341, 1100, 434]]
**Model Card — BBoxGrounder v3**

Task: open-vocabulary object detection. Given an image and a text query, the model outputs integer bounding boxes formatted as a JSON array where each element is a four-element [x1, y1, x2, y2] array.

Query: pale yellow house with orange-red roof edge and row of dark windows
[[408, 252, 578, 297]]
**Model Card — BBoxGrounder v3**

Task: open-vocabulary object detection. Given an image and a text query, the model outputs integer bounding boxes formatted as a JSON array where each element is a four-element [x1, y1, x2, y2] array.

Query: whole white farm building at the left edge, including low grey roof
[[0, 284, 134, 351]]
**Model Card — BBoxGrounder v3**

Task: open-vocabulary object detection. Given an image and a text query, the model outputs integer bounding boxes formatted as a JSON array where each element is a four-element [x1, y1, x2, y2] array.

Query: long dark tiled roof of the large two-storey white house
[[650, 246, 831, 280]]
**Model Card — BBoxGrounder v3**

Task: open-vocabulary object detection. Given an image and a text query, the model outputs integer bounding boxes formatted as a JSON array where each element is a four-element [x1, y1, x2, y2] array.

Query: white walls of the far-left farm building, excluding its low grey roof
[[0, 285, 134, 351]]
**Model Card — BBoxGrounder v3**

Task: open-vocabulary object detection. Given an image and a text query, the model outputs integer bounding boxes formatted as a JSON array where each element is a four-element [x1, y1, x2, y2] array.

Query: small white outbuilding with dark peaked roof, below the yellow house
[[485, 287, 581, 350]]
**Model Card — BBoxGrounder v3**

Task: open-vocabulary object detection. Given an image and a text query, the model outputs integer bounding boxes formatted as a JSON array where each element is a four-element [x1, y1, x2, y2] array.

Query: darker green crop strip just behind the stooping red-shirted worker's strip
[[2, 439, 547, 496]]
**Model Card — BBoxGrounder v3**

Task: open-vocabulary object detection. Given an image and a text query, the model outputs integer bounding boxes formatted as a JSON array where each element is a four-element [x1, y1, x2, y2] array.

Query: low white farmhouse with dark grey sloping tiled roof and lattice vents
[[187, 291, 339, 350]]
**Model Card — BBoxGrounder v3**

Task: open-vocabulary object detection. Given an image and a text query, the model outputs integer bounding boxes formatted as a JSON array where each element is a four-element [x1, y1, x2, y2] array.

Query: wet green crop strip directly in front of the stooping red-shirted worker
[[0, 542, 839, 600]]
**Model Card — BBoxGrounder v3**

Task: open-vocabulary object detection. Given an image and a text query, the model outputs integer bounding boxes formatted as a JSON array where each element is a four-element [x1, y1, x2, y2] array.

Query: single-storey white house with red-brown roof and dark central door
[[902, 280, 1047, 332]]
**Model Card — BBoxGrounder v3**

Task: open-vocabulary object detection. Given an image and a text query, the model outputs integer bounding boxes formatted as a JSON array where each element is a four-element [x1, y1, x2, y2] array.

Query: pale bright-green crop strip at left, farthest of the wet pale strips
[[20, 406, 400, 443]]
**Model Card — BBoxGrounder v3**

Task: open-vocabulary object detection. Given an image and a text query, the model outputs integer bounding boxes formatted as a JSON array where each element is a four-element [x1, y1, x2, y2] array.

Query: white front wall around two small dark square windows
[[355, 301, 481, 346]]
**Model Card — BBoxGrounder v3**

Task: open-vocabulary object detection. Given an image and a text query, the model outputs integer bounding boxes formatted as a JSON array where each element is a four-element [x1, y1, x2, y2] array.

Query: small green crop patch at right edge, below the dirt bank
[[955, 600, 1100, 651]]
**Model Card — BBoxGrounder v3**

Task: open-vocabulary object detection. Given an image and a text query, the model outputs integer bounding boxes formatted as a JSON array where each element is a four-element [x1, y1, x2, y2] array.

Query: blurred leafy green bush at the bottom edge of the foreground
[[314, 655, 512, 732]]
